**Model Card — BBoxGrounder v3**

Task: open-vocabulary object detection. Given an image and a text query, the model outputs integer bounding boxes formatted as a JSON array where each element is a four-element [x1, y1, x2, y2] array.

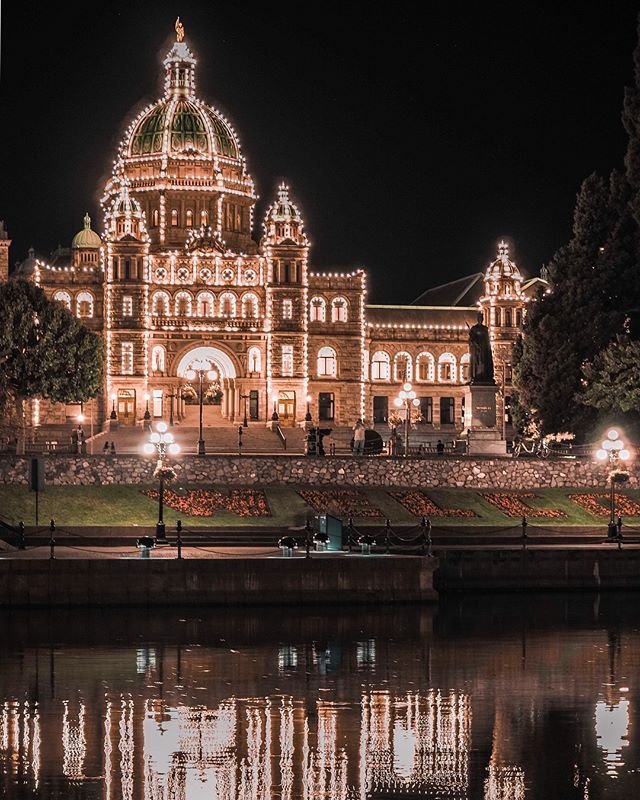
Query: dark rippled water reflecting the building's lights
[[0, 593, 640, 800]]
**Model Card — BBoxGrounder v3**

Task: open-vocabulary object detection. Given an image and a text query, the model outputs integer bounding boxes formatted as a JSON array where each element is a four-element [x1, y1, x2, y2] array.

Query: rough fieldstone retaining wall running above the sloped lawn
[[0, 455, 639, 489]]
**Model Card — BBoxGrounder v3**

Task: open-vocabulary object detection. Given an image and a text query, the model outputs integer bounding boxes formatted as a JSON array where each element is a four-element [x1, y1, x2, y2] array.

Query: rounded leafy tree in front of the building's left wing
[[0, 279, 103, 444]]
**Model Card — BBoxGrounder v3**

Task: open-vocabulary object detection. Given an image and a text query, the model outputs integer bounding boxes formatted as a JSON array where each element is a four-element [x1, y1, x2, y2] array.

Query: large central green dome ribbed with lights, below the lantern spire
[[126, 97, 240, 159]]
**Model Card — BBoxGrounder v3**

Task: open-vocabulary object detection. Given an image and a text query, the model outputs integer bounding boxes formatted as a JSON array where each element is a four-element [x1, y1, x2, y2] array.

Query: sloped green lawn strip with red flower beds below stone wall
[[0, 486, 640, 529]]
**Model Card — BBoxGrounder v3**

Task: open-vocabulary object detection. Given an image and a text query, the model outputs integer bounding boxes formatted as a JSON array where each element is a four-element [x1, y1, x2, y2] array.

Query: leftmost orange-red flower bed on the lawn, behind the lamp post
[[142, 489, 271, 517]]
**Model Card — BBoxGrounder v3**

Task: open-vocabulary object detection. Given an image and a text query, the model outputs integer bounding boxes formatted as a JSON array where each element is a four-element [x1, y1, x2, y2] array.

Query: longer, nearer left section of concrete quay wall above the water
[[0, 554, 437, 608]]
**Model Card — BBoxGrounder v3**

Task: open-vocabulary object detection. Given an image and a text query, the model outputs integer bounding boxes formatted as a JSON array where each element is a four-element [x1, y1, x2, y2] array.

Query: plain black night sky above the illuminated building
[[0, 0, 640, 303]]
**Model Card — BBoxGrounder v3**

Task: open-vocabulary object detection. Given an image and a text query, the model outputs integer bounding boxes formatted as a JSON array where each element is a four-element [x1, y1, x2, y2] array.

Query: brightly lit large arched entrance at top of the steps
[[176, 346, 236, 425]]
